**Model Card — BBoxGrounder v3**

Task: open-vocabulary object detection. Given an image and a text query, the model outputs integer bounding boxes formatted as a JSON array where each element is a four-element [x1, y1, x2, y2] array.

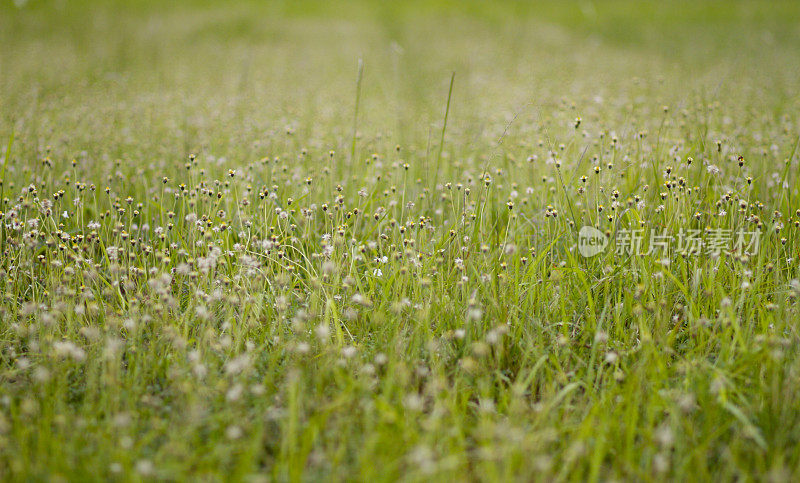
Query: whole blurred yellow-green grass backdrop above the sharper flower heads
[[0, 0, 800, 169]]
